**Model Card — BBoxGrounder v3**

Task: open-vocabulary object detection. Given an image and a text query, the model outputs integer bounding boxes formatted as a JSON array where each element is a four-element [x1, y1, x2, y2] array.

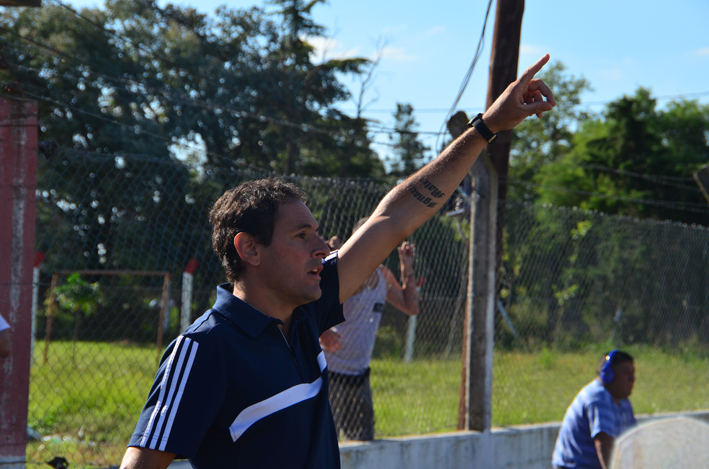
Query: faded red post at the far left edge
[[0, 97, 37, 469]]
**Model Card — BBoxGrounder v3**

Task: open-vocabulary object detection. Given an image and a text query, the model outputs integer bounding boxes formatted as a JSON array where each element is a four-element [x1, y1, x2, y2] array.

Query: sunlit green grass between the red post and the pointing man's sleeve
[[27, 342, 157, 467]]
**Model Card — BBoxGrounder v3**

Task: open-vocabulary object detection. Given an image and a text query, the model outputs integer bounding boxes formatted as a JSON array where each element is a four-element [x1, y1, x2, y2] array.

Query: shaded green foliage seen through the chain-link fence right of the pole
[[496, 204, 709, 350]]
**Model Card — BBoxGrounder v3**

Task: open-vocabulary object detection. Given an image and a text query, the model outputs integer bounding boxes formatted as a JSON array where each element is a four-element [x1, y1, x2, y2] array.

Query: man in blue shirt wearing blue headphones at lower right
[[552, 350, 637, 469]]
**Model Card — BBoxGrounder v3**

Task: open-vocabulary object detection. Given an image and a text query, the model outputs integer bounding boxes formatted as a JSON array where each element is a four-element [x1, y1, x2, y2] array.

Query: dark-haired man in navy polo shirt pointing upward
[[121, 55, 555, 469]]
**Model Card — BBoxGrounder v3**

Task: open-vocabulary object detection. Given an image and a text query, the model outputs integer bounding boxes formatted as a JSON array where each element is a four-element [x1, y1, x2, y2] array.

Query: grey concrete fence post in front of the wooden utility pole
[[463, 154, 497, 431]]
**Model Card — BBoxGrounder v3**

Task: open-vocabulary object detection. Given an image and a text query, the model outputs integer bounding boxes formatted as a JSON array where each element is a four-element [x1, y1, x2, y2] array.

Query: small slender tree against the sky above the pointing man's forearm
[[389, 103, 429, 177]]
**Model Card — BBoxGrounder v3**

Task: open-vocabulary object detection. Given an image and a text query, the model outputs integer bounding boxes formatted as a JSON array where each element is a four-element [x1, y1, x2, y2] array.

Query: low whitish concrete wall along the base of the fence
[[340, 411, 709, 469]]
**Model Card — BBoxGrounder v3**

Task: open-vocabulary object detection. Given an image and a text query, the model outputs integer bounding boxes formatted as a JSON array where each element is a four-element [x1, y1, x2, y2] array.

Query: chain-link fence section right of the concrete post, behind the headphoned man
[[493, 203, 709, 425]]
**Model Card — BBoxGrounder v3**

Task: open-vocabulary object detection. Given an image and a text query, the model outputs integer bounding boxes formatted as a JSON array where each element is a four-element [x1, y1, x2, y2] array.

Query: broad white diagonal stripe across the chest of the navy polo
[[229, 352, 327, 442]]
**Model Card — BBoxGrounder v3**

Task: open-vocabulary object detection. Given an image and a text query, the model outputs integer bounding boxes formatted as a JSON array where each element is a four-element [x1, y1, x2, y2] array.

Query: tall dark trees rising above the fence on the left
[[0, 0, 383, 177]]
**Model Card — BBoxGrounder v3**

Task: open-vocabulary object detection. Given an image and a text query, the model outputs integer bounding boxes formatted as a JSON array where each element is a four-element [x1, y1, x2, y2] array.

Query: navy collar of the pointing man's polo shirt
[[212, 283, 303, 338]]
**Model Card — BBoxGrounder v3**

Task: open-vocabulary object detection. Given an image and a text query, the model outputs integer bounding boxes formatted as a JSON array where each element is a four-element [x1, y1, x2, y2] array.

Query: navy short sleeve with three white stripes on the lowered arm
[[128, 335, 226, 458]]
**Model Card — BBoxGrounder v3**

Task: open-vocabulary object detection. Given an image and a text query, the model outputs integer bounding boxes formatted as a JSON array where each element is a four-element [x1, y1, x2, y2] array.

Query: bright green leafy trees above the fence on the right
[[535, 88, 709, 225]]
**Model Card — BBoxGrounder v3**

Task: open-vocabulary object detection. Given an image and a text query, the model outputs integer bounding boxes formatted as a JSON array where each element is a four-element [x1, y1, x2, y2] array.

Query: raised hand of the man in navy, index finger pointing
[[483, 54, 556, 132]]
